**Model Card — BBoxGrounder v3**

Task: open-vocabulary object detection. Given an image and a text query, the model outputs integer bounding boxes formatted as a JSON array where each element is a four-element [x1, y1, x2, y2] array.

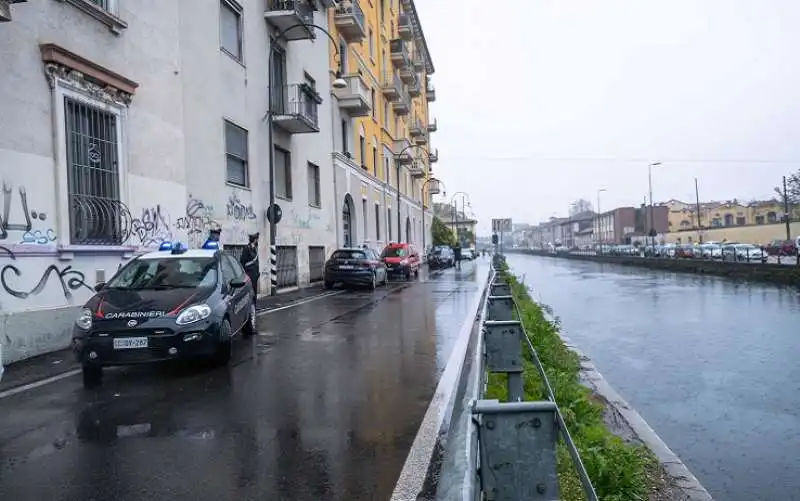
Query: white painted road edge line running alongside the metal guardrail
[[390, 270, 489, 501]]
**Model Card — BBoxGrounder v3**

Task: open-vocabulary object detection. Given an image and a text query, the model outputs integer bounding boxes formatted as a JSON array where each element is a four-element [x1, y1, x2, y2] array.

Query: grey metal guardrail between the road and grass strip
[[461, 254, 598, 501]]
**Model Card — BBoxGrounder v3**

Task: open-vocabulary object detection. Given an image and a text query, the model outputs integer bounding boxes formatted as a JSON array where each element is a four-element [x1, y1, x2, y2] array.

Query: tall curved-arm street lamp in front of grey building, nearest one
[[264, 23, 347, 296]]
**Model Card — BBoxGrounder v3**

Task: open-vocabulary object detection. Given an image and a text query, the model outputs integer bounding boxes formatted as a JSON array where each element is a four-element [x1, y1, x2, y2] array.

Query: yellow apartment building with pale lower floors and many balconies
[[328, 0, 439, 248]]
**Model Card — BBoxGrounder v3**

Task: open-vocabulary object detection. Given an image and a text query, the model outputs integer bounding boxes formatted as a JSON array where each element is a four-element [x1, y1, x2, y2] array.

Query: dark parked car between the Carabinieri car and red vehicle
[[324, 248, 387, 290]]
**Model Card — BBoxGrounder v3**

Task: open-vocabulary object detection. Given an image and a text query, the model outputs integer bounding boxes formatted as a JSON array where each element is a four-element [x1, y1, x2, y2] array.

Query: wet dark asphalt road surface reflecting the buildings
[[0, 261, 488, 501]]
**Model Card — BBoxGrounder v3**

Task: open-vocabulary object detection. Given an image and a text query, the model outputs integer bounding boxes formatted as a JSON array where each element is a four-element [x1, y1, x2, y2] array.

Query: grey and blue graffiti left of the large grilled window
[[0, 180, 56, 245]]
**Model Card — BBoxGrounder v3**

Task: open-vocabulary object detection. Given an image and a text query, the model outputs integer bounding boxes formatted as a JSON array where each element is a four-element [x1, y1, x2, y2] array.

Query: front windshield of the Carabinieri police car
[[106, 257, 217, 290]]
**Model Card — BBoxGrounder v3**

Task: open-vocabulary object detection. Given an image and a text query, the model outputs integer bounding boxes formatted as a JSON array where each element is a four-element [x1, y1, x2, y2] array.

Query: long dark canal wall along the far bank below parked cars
[[507, 249, 800, 285]]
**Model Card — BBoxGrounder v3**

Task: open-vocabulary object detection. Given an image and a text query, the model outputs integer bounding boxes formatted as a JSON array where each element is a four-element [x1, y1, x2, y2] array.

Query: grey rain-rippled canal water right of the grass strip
[[508, 255, 800, 501]]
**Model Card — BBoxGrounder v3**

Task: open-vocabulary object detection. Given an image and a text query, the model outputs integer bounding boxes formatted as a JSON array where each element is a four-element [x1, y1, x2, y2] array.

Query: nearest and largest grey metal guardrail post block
[[472, 400, 559, 501]]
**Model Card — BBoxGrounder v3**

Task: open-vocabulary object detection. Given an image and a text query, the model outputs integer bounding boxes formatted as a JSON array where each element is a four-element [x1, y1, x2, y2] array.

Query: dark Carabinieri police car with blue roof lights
[[72, 241, 256, 387]]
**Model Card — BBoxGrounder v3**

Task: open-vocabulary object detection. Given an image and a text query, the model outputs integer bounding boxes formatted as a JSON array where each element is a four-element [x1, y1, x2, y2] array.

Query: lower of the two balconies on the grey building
[[272, 84, 322, 134]]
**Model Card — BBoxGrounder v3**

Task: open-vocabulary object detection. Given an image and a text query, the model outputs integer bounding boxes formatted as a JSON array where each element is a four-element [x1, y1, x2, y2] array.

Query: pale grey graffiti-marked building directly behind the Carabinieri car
[[0, 0, 352, 363]]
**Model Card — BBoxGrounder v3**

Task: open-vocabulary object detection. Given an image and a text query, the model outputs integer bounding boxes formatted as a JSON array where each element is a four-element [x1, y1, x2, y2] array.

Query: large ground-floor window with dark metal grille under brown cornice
[[64, 98, 125, 245]]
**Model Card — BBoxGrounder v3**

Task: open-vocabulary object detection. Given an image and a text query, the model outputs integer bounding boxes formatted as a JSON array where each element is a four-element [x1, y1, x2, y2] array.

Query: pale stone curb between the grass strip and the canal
[[559, 333, 714, 501]]
